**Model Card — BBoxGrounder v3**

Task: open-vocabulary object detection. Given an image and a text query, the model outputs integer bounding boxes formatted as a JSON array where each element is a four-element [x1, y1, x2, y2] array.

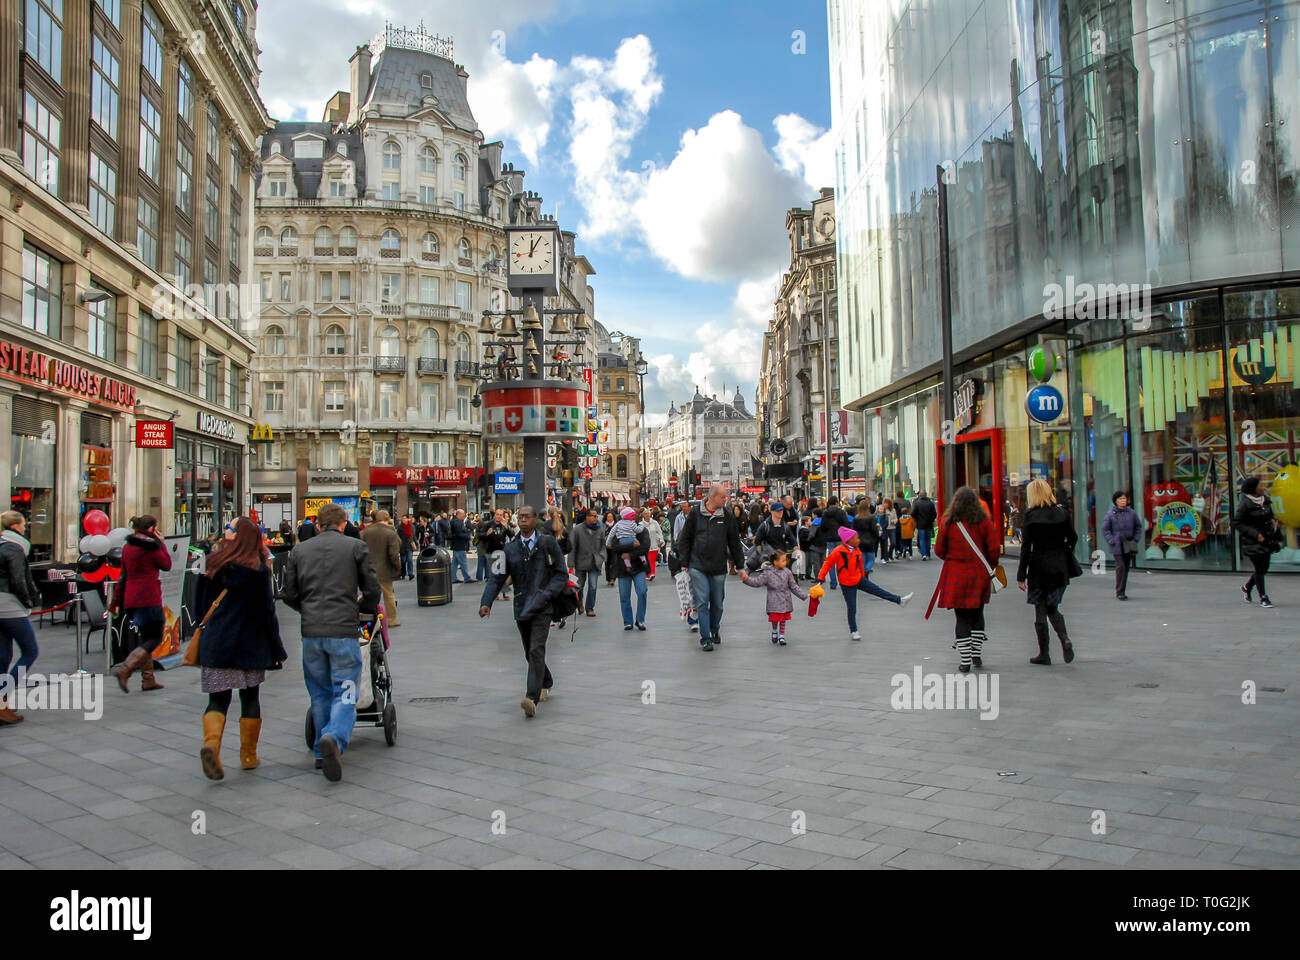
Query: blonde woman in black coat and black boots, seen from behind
[[1015, 477, 1083, 665]]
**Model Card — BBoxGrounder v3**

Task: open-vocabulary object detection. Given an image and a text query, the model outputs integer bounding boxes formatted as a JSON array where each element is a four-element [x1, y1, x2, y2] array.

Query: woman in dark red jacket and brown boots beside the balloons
[[113, 514, 172, 693]]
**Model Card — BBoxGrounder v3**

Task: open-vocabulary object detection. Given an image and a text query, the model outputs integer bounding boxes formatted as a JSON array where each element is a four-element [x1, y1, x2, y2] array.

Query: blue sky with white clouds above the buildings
[[257, 0, 833, 425]]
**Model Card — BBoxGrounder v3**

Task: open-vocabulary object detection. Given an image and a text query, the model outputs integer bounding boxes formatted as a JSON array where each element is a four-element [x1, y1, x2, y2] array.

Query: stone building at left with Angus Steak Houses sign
[[0, 0, 270, 565]]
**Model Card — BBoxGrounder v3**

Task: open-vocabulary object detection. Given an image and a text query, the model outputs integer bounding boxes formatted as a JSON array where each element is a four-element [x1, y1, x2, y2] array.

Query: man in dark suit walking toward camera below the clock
[[478, 506, 568, 718]]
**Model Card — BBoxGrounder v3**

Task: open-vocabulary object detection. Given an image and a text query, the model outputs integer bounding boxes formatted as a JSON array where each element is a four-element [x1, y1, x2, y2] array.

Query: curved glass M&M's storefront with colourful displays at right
[[866, 280, 1300, 572]]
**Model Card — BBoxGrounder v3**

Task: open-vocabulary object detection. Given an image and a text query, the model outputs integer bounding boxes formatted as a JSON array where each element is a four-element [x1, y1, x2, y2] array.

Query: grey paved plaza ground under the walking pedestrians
[[0, 559, 1300, 870]]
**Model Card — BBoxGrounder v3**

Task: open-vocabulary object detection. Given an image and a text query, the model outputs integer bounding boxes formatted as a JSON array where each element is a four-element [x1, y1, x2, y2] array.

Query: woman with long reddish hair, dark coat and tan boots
[[195, 516, 287, 780]]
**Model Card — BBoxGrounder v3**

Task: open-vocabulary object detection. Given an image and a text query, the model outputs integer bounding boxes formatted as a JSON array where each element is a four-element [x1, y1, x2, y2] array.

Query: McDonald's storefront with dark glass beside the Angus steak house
[[172, 411, 247, 541]]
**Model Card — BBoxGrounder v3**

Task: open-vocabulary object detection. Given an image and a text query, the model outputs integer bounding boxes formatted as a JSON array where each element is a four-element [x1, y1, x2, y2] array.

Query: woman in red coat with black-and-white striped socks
[[927, 487, 1002, 674]]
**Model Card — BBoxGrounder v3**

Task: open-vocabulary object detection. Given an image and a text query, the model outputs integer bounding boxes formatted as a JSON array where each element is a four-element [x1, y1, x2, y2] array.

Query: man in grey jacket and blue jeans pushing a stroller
[[280, 503, 381, 782]]
